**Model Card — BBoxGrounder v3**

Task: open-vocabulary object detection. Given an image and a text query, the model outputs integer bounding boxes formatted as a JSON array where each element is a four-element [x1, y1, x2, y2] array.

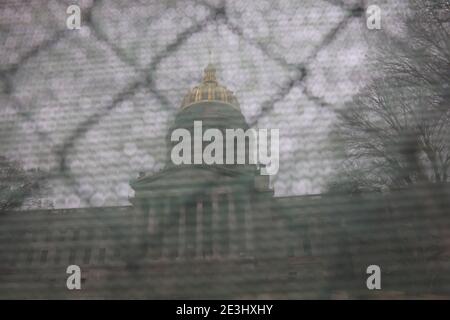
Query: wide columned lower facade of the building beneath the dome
[[0, 185, 450, 299]]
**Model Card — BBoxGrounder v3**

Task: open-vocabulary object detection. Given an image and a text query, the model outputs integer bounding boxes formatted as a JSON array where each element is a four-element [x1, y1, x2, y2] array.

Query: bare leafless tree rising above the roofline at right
[[328, 0, 450, 192]]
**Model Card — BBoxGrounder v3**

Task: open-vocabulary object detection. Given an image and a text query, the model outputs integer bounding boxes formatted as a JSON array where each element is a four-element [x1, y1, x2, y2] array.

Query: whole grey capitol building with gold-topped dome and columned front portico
[[0, 64, 448, 299]]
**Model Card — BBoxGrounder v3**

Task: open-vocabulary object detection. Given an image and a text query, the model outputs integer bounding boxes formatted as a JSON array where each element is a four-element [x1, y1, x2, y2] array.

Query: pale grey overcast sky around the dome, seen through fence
[[0, 0, 405, 208]]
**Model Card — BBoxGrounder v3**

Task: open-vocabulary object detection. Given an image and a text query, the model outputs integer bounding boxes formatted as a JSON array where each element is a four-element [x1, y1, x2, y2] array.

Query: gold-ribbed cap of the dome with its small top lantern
[[181, 64, 239, 109]]
